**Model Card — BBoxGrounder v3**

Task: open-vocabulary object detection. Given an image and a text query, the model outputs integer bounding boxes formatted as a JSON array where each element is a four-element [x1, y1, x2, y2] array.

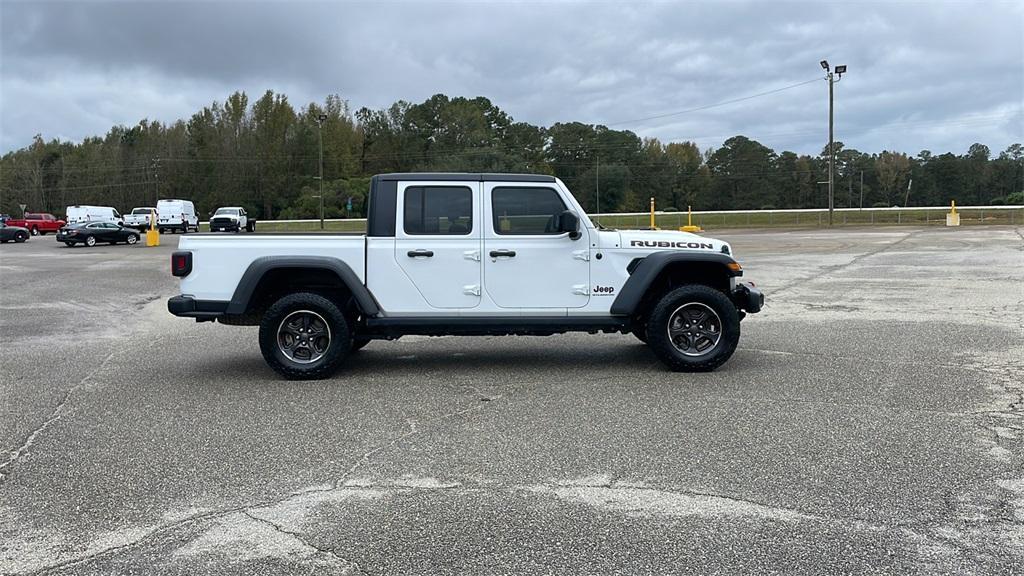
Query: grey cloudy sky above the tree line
[[0, 0, 1024, 154]]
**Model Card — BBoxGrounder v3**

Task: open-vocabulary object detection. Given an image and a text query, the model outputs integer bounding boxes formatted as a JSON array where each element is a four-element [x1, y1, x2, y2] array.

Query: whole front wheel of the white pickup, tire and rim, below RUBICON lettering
[[647, 284, 739, 372]]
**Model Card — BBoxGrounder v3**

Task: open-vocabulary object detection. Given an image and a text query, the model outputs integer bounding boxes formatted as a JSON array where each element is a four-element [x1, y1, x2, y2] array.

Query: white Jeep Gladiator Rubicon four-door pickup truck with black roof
[[167, 173, 764, 379]]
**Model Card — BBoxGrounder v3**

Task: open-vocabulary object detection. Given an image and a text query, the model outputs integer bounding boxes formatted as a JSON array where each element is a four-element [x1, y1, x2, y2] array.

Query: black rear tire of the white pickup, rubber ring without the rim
[[259, 292, 352, 380]]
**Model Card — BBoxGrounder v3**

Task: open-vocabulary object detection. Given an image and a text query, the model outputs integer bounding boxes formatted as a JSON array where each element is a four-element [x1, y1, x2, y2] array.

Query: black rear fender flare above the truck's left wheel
[[224, 256, 380, 317]]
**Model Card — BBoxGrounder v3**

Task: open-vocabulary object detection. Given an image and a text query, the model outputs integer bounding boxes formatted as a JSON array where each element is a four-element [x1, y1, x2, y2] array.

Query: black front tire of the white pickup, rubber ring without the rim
[[647, 284, 739, 372]]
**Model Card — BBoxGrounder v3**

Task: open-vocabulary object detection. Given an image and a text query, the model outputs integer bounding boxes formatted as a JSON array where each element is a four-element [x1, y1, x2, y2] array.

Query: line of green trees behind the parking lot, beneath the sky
[[0, 91, 1024, 219]]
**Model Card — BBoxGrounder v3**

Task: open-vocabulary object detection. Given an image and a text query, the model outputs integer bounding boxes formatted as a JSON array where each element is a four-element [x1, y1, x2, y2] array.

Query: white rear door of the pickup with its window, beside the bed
[[394, 181, 482, 311]]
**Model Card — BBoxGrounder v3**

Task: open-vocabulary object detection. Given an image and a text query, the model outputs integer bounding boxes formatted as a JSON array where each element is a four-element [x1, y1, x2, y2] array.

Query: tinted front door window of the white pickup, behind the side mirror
[[490, 187, 566, 236]]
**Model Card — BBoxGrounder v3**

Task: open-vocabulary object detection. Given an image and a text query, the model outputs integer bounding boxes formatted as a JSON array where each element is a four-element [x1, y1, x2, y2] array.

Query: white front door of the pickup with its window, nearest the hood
[[483, 182, 590, 308]]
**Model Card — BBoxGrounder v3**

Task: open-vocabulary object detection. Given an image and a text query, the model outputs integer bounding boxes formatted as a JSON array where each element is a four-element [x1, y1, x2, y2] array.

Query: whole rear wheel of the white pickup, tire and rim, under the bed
[[259, 292, 352, 380]]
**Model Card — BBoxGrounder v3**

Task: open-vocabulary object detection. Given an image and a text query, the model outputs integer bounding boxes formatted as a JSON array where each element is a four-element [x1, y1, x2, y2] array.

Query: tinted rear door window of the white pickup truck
[[403, 186, 473, 236]]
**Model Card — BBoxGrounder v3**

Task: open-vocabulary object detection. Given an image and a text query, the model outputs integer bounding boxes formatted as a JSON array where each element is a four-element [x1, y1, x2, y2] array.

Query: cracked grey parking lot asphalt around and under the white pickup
[[0, 227, 1024, 575]]
